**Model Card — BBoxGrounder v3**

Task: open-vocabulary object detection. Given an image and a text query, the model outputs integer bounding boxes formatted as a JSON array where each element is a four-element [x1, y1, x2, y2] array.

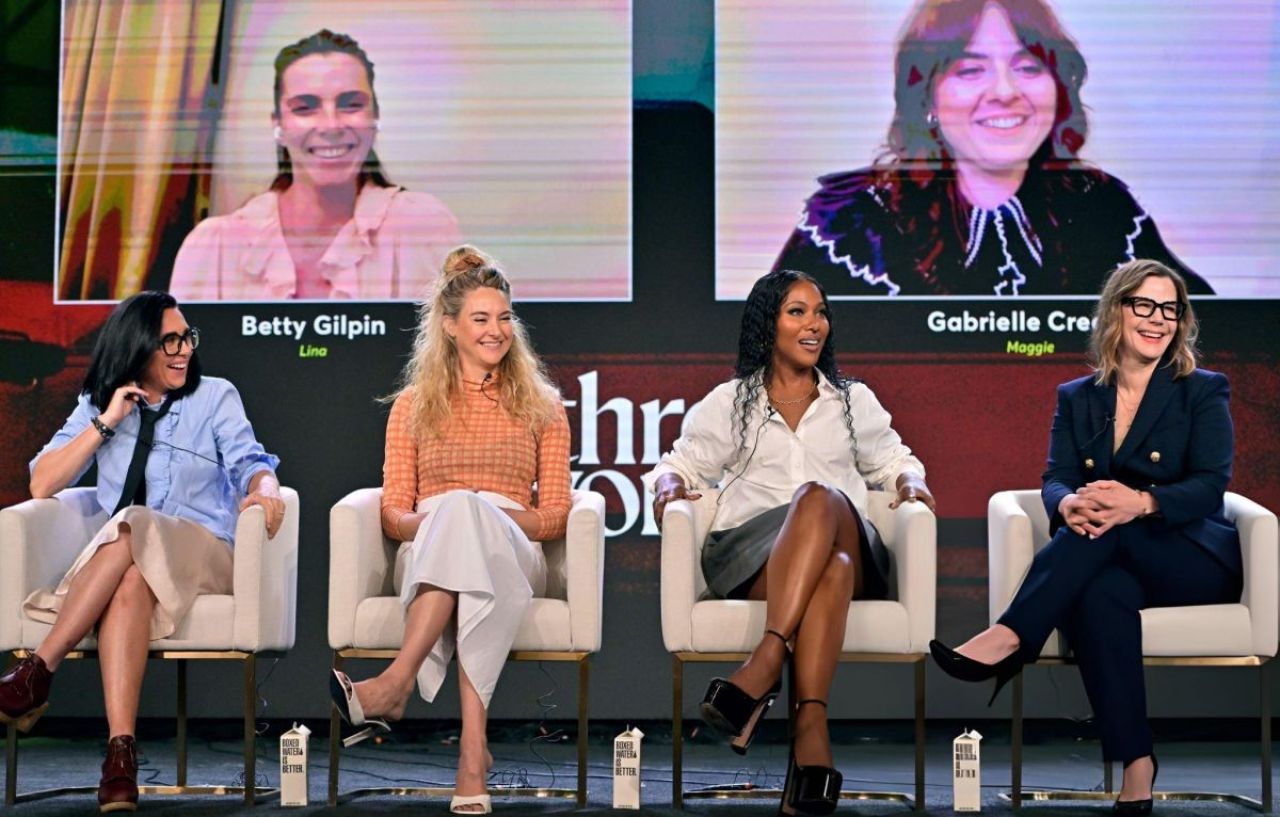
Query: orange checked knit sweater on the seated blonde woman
[[383, 382, 570, 542]]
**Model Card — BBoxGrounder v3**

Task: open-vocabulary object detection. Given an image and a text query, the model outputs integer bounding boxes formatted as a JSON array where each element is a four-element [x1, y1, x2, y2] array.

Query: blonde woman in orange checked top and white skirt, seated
[[330, 246, 570, 813]]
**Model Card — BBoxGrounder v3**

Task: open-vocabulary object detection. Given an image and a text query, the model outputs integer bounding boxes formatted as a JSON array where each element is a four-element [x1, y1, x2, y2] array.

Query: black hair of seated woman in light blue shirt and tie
[[81, 289, 201, 411]]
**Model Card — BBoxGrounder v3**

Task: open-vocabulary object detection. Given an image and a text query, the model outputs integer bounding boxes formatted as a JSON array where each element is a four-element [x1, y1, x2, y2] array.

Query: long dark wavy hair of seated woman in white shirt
[[732, 269, 858, 461]]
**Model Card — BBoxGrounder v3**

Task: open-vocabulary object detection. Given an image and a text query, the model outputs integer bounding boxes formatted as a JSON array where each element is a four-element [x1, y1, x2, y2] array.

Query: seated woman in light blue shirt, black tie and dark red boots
[[0, 292, 284, 812]]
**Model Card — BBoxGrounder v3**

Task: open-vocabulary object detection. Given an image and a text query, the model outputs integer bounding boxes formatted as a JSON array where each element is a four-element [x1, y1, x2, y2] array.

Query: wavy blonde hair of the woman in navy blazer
[[1089, 259, 1199, 385]]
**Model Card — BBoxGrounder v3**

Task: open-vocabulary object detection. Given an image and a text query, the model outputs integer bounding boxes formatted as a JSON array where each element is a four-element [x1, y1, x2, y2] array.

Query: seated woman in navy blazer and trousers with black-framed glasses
[[931, 260, 1242, 814]]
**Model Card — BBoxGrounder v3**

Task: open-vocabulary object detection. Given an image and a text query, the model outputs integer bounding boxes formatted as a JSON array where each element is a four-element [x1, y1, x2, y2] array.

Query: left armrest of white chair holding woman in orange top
[[329, 488, 398, 649]]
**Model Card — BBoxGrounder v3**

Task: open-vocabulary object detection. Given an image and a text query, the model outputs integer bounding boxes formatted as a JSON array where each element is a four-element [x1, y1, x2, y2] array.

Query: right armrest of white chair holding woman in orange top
[[564, 490, 604, 652]]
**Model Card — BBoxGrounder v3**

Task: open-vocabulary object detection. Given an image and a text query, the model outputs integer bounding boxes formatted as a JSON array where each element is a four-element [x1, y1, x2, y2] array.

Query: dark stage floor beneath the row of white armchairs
[[12, 721, 1261, 817]]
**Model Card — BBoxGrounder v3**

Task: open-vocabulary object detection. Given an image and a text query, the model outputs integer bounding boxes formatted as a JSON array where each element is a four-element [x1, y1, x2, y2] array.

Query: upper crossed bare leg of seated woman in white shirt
[[730, 483, 861, 697]]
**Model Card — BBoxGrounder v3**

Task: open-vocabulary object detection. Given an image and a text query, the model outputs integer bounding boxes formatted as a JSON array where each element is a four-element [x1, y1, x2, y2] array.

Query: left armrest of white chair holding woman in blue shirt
[[0, 488, 109, 649]]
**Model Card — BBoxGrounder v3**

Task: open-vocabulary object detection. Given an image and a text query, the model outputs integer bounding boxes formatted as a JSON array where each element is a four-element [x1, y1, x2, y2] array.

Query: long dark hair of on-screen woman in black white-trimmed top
[[874, 0, 1089, 292]]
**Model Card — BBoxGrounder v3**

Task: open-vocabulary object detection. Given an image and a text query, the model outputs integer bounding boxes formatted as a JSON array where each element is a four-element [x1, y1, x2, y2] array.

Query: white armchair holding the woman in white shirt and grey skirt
[[662, 490, 937, 809]]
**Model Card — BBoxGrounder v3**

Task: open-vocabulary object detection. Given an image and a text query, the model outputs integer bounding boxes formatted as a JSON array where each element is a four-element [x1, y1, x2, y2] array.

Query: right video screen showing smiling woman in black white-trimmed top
[[716, 0, 1280, 300]]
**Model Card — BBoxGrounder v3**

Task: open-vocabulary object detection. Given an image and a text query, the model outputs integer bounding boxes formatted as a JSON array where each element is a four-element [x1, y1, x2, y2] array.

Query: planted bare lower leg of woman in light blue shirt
[[97, 565, 156, 738]]
